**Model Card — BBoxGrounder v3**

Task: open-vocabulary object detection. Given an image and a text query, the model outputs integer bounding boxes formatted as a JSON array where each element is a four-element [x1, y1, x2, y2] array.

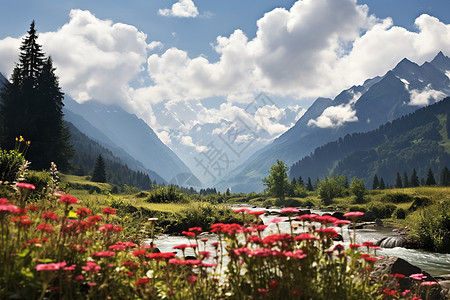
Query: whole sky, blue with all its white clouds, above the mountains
[[0, 0, 450, 183]]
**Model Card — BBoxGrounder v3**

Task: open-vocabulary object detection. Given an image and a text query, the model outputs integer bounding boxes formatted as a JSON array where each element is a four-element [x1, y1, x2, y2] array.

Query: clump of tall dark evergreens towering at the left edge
[[0, 21, 73, 170]]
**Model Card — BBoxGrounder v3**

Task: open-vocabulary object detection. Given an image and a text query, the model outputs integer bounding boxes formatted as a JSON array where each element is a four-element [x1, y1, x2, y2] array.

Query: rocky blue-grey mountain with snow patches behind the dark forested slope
[[217, 52, 450, 192]]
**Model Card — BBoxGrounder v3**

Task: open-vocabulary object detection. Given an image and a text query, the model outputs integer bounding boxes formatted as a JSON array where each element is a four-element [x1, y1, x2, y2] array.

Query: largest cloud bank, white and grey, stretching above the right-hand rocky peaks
[[136, 0, 450, 103]]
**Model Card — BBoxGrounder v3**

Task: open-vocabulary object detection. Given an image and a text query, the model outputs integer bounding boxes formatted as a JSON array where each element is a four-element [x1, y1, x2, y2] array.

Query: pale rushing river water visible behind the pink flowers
[[149, 208, 450, 276]]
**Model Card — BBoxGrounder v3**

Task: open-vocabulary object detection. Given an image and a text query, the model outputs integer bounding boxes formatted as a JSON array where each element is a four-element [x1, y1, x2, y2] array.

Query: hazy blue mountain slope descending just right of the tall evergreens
[[65, 97, 200, 181]]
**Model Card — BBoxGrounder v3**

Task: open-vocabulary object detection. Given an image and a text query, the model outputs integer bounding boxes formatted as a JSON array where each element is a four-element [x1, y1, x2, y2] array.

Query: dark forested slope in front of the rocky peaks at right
[[290, 97, 450, 186]]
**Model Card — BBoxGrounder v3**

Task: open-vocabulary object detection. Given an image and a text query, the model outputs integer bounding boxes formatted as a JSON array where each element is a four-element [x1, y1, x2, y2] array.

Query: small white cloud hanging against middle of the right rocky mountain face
[[308, 104, 358, 128]]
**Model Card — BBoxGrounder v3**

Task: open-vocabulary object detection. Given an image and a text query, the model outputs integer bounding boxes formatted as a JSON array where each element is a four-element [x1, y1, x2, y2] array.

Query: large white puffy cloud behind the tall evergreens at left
[[0, 9, 149, 104]]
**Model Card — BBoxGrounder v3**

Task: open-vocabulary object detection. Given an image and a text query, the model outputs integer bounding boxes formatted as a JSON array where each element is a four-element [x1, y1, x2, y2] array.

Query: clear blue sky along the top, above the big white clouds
[[0, 0, 450, 59]]
